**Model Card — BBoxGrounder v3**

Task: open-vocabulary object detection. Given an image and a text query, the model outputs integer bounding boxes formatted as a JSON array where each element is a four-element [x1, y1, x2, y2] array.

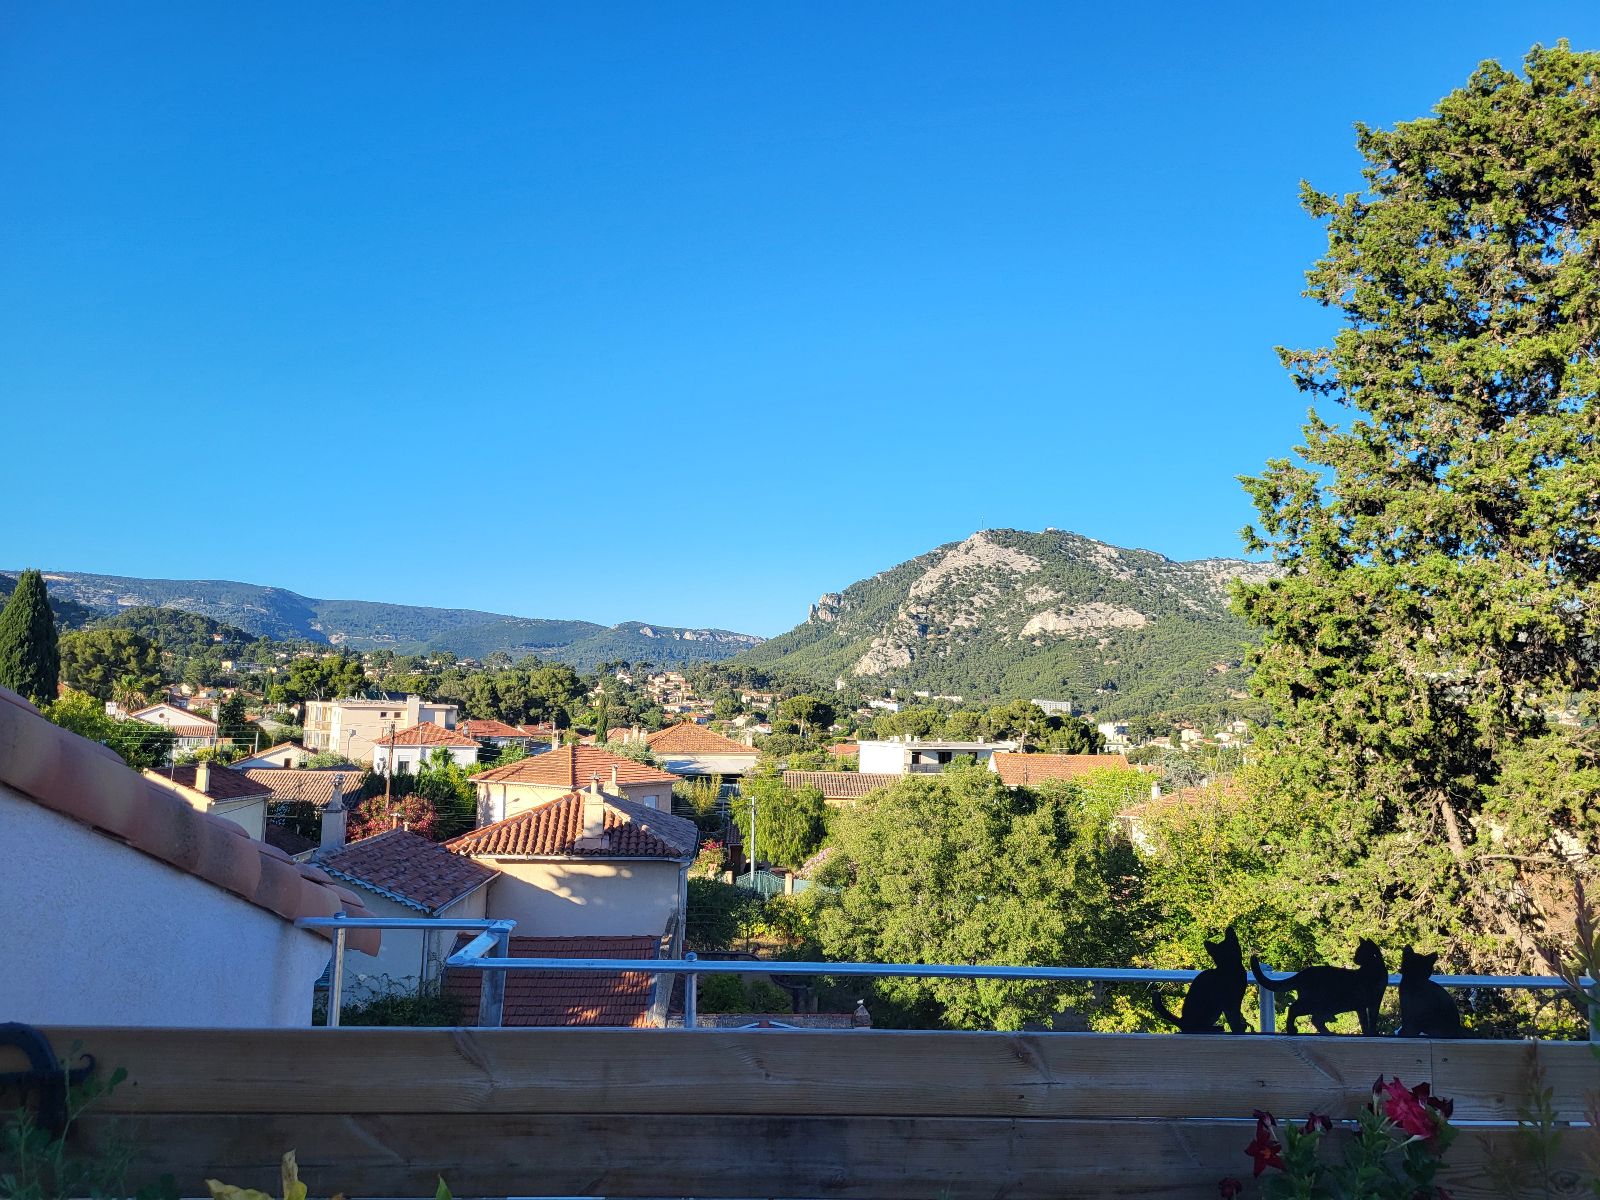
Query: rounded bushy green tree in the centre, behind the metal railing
[[816, 768, 1149, 1029]]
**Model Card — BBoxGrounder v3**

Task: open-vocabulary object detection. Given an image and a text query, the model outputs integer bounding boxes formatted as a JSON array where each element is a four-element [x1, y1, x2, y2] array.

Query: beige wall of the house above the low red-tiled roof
[[478, 858, 688, 938]]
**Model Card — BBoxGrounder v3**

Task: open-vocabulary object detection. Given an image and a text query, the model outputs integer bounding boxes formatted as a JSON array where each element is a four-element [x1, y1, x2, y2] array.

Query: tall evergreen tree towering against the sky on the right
[[1242, 43, 1600, 968]]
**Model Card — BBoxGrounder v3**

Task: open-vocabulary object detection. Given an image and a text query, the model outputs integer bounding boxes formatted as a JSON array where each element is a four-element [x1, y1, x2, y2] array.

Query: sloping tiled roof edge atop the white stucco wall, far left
[[0, 688, 378, 954]]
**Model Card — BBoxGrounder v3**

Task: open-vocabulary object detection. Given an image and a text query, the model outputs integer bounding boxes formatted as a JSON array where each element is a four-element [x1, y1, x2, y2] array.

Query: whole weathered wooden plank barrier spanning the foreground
[[31, 1029, 1600, 1200]]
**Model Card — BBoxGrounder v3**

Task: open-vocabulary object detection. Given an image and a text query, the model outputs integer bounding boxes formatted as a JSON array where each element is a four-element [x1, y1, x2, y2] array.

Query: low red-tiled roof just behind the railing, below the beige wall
[[445, 936, 661, 1027]]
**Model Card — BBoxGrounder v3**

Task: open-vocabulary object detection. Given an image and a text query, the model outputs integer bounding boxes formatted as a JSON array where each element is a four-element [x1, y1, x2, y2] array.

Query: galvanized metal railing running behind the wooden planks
[[296, 914, 1600, 1043]]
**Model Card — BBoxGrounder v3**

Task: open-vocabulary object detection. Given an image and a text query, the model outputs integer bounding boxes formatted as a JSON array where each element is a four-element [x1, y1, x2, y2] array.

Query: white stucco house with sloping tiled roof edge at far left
[[0, 688, 379, 1029]]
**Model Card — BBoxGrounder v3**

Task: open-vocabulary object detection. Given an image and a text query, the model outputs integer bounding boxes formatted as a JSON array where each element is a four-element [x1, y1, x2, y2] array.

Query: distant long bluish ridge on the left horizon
[[0, 571, 760, 670]]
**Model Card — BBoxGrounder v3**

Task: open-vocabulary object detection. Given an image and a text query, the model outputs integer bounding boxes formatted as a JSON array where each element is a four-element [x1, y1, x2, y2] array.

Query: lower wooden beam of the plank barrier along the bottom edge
[[85, 1114, 1574, 1200]]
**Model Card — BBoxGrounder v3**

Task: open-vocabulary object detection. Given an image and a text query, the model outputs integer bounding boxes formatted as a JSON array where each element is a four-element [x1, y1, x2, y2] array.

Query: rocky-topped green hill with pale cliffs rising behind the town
[[739, 530, 1269, 718]]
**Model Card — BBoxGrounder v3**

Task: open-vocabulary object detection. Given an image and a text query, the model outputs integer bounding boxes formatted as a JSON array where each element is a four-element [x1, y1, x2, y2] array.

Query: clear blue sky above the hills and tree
[[0, 0, 1600, 634]]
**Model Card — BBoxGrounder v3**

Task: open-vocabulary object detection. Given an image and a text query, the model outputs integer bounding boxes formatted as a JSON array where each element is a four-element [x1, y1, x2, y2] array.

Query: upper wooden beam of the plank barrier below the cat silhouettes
[[48, 1029, 1452, 1118]]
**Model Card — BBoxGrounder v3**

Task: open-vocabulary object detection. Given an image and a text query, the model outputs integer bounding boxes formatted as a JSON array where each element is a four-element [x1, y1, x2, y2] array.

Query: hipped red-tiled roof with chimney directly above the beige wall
[[445, 792, 699, 859]]
